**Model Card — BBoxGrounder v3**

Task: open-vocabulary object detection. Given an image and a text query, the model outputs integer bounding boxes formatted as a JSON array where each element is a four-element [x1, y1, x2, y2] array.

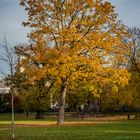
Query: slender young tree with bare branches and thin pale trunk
[[0, 37, 17, 140]]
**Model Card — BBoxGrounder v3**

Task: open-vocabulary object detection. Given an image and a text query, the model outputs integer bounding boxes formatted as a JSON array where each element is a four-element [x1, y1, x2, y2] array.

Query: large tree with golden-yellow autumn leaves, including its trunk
[[19, 0, 128, 124]]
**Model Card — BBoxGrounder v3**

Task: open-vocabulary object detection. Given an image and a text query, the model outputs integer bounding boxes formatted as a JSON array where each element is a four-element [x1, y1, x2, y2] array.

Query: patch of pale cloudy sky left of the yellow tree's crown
[[0, 0, 28, 46]]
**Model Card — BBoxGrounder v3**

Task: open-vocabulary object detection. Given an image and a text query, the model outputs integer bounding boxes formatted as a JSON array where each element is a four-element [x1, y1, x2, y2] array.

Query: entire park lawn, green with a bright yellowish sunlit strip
[[0, 114, 140, 140]]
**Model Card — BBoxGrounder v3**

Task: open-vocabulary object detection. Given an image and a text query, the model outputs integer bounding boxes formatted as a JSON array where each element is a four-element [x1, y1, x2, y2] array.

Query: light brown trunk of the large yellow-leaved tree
[[57, 83, 67, 125]]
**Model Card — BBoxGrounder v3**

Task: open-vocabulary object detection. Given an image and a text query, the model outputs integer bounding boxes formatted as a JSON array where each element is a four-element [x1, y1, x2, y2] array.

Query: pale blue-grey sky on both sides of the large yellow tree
[[0, 0, 140, 77]]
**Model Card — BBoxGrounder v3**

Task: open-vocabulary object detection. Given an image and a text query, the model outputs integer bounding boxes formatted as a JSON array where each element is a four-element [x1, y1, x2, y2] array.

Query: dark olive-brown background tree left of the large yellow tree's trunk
[[14, 66, 50, 119]]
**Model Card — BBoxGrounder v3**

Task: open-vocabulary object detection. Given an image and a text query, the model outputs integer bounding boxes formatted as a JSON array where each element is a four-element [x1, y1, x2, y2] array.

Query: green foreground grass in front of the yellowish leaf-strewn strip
[[0, 121, 140, 140]]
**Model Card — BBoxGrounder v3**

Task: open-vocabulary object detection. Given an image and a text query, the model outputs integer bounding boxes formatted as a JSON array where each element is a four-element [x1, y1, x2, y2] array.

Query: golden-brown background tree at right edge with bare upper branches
[[104, 28, 140, 119]]
